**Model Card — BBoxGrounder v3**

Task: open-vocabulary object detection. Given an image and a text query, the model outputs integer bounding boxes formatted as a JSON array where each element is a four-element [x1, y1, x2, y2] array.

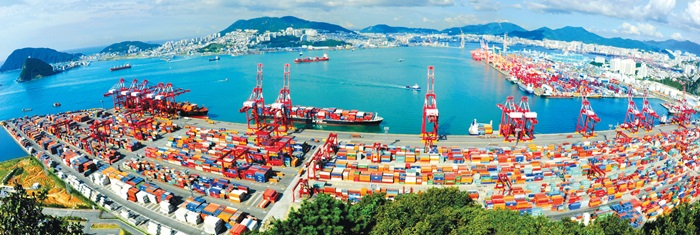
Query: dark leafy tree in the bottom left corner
[[0, 184, 83, 235]]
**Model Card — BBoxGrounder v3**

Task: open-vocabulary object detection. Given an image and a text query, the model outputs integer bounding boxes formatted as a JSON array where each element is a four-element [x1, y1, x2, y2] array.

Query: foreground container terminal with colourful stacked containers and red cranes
[[2, 65, 700, 234]]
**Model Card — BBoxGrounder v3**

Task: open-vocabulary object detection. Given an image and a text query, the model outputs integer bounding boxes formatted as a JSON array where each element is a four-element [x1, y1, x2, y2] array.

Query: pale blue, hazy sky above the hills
[[0, 0, 700, 60]]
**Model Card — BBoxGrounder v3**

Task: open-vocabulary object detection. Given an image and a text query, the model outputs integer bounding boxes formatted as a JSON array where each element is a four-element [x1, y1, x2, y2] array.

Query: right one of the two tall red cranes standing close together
[[270, 64, 293, 132]]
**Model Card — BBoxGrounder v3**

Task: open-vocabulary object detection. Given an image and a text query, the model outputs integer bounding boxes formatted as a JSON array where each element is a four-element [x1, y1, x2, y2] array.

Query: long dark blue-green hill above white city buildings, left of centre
[[221, 16, 354, 35]]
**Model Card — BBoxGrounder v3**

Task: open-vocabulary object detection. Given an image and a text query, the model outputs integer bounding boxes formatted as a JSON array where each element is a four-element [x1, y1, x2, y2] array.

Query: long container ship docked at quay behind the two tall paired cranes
[[263, 106, 384, 126]]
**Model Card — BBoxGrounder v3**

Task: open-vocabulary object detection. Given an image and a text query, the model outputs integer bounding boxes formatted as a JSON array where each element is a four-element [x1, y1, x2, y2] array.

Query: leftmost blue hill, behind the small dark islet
[[0, 47, 83, 72]]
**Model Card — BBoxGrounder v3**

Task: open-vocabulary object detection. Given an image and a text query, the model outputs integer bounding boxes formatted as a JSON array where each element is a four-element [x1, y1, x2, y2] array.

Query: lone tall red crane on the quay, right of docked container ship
[[421, 66, 439, 152]]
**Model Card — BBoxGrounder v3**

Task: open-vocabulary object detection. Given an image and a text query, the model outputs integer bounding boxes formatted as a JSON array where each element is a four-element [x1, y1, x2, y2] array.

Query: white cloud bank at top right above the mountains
[[526, 0, 680, 23]]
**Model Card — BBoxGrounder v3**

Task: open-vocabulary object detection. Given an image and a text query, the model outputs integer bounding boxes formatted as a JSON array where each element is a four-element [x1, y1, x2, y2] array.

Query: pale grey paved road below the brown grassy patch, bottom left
[[42, 208, 144, 235]]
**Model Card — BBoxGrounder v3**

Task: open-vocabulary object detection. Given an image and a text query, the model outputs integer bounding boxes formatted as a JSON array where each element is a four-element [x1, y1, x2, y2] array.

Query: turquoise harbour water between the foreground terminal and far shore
[[0, 43, 667, 160]]
